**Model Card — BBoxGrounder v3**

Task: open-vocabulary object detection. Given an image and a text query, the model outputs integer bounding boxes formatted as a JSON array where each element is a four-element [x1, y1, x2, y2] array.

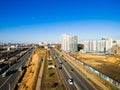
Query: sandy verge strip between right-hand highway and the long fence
[[56, 49, 119, 90]]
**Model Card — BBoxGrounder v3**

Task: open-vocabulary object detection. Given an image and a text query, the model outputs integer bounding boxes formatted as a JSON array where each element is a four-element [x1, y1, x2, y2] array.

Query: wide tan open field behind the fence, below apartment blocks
[[70, 53, 120, 82]]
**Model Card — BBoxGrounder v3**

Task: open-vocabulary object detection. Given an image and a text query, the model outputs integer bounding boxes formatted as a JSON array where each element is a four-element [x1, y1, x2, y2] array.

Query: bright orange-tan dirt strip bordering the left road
[[18, 49, 46, 90]]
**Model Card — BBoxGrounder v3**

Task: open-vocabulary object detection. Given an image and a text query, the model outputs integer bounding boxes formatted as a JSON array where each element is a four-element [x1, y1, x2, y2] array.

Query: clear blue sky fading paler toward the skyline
[[0, 0, 120, 42]]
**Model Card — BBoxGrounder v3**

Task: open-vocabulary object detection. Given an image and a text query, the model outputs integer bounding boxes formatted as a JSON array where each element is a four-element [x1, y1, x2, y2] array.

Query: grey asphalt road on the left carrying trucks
[[0, 49, 33, 90]]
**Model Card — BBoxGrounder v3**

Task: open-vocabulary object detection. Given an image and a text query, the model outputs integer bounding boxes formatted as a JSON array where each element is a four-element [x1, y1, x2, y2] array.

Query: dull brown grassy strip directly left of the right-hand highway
[[41, 51, 65, 90]]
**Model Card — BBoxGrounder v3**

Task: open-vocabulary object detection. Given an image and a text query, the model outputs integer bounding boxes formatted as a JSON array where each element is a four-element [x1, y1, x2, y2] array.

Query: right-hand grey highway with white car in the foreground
[[51, 48, 96, 90]]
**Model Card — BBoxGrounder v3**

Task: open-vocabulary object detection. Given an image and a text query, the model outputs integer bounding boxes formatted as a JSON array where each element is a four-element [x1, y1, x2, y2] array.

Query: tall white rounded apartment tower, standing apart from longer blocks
[[61, 34, 78, 52]]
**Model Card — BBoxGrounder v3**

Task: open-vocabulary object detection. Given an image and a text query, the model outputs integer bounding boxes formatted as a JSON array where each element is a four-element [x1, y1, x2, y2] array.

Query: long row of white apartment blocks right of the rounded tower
[[83, 37, 113, 54]]
